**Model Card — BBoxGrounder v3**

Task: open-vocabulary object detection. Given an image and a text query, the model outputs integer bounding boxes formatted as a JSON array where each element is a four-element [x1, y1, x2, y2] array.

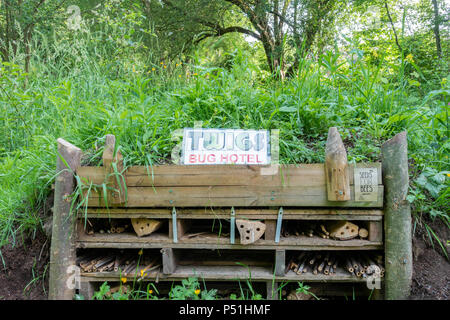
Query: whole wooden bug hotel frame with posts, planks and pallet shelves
[[49, 128, 412, 299]]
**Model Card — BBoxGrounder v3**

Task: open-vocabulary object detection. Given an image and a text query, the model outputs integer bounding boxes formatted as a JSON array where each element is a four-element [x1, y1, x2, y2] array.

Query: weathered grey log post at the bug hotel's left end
[[49, 138, 82, 300]]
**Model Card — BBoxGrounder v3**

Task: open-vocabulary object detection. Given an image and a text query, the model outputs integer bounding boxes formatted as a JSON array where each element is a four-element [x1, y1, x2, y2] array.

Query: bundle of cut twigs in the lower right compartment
[[285, 252, 384, 278]]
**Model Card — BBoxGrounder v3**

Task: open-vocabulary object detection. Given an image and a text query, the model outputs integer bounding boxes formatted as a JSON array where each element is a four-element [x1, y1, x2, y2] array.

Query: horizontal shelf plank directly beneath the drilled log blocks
[[77, 233, 383, 250]]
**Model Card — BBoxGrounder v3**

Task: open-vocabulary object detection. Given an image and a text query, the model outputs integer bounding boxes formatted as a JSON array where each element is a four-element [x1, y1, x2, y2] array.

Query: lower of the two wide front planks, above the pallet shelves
[[83, 186, 383, 208]]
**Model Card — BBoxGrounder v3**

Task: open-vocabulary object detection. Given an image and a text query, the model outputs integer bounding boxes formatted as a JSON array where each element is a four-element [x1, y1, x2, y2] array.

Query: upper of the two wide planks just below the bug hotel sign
[[77, 163, 382, 187]]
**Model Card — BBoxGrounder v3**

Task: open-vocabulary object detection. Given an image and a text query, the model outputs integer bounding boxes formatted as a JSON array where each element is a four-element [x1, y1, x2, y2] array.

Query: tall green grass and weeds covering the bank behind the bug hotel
[[0, 30, 450, 258]]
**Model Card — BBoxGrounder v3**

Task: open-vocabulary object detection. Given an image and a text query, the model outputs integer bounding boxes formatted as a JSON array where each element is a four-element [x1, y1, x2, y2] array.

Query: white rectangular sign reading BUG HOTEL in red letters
[[181, 128, 270, 165]]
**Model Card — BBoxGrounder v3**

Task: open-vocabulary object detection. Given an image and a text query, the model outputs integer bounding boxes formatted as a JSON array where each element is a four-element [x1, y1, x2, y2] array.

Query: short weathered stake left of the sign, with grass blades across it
[[102, 134, 126, 204]]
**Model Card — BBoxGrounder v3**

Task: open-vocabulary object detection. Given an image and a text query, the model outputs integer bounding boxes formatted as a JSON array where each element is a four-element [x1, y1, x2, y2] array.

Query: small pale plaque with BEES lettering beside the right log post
[[354, 168, 378, 201]]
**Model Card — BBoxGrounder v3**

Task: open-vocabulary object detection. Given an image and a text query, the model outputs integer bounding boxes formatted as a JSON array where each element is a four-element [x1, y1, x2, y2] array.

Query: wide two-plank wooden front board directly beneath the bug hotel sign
[[77, 163, 383, 207]]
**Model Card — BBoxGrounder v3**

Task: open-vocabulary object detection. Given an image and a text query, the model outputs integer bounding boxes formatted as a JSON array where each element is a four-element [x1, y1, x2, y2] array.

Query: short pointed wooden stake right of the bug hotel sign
[[325, 127, 351, 201]]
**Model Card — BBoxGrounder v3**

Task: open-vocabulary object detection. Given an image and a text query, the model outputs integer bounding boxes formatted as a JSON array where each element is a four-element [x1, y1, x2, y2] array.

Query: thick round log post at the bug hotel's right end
[[381, 131, 412, 300]]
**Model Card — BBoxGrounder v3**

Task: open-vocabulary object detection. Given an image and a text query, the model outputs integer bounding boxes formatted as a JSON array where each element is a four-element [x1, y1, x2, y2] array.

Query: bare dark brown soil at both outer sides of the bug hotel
[[0, 218, 450, 300]]
